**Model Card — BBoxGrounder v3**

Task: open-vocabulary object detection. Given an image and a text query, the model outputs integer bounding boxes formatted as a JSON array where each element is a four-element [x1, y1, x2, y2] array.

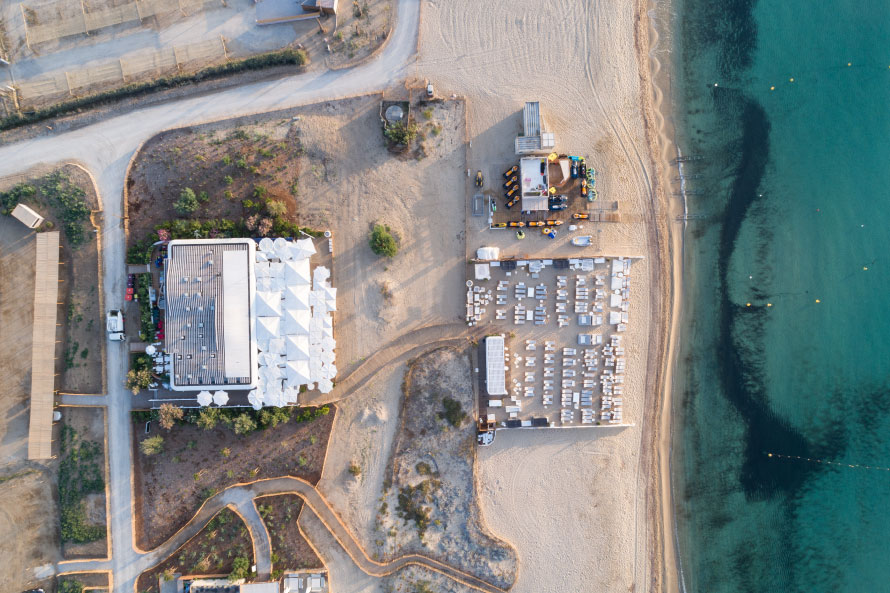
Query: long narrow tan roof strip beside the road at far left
[[28, 231, 59, 459]]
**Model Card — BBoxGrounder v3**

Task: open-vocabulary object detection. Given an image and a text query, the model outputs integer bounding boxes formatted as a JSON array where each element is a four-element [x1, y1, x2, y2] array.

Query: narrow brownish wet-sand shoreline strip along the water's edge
[[635, 0, 685, 593]]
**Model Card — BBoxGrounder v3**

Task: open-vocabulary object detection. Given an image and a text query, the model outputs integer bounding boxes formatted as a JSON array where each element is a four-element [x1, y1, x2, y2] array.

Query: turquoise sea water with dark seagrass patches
[[673, 0, 890, 593]]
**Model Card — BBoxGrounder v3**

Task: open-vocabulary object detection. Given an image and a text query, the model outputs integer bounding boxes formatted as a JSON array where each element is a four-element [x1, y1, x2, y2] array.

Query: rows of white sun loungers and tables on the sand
[[478, 258, 631, 426]]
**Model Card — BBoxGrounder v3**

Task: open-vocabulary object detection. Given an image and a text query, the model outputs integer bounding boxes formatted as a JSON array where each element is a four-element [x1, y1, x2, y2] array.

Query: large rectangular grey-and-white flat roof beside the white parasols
[[164, 239, 257, 391]]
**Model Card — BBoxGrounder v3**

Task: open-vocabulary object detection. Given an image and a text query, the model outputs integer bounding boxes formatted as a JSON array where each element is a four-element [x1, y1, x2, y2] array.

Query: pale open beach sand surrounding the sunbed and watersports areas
[[417, 0, 661, 593]]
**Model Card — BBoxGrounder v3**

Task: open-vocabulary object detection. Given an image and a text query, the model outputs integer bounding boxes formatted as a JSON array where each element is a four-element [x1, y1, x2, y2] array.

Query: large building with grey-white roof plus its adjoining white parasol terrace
[[160, 238, 337, 409]]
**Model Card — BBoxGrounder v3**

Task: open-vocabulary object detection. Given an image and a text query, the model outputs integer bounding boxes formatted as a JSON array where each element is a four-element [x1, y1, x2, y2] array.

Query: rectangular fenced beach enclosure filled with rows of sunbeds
[[467, 257, 639, 428]]
